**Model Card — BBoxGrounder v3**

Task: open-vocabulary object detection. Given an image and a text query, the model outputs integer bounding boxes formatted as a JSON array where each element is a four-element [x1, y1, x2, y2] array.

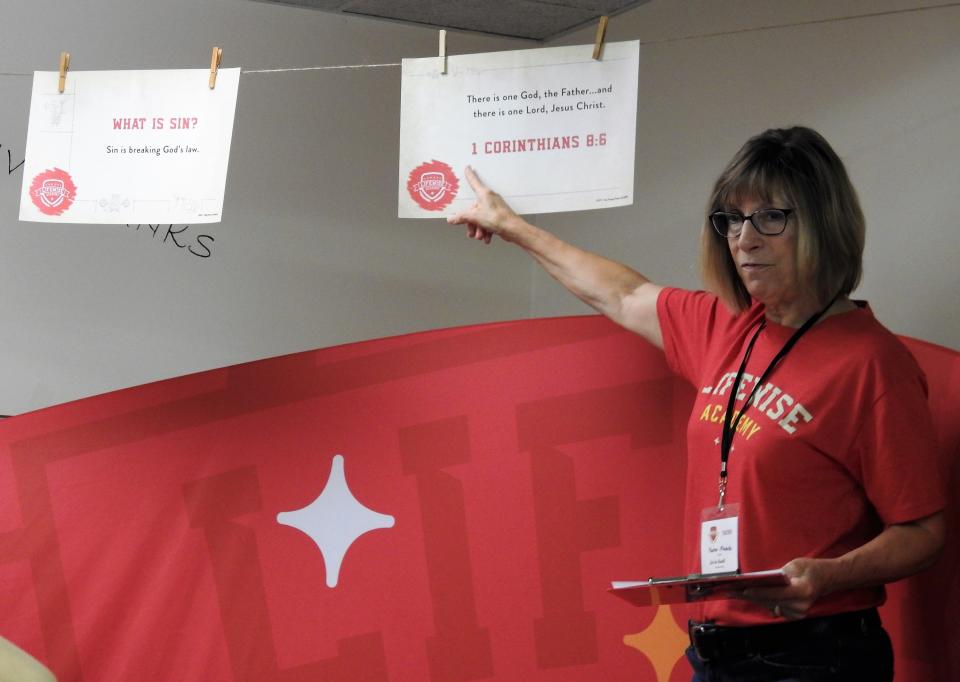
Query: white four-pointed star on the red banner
[[277, 455, 394, 587]]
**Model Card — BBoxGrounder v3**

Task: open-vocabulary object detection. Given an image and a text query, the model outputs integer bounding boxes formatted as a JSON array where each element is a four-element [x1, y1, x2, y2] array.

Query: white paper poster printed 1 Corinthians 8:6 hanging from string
[[398, 41, 640, 218]]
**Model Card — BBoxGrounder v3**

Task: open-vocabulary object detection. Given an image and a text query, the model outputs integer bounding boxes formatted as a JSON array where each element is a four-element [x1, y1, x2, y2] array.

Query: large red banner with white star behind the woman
[[0, 317, 960, 682]]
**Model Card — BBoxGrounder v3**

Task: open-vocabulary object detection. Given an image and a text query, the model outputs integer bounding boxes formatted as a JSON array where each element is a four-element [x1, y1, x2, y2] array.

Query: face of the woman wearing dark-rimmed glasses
[[727, 194, 816, 316]]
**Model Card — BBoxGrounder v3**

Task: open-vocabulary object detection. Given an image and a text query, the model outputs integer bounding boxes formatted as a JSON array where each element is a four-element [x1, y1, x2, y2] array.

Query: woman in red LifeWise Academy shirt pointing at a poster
[[448, 127, 944, 681]]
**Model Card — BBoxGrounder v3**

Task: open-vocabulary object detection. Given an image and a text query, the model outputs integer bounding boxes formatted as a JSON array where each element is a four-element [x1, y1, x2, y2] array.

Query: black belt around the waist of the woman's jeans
[[689, 609, 881, 662]]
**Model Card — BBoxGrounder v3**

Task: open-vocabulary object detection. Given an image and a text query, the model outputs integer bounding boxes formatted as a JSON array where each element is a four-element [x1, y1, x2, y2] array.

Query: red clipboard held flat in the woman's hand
[[609, 568, 790, 606]]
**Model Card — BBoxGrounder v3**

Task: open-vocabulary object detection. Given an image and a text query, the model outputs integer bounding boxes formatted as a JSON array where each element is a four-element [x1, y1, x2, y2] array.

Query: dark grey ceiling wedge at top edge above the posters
[[249, 0, 649, 41]]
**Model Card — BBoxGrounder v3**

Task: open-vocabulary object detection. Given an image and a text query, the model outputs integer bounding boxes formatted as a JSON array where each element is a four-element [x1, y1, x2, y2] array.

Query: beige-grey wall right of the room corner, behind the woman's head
[[532, 0, 960, 348]]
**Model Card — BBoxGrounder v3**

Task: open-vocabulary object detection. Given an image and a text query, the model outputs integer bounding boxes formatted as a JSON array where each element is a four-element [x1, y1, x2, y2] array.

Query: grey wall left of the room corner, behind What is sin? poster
[[0, 0, 531, 414]]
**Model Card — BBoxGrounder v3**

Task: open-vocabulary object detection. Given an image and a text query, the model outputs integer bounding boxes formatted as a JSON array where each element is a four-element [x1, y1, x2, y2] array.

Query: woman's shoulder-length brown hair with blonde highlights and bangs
[[700, 126, 866, 312]]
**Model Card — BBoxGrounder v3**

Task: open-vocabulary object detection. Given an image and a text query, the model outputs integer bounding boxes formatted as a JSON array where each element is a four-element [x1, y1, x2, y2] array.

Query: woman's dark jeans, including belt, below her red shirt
[[687, 617, 893, 682]]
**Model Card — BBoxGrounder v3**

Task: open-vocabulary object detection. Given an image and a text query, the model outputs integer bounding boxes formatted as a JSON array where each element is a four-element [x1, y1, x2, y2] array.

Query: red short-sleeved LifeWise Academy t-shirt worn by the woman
[[657, 289, 944, 625]]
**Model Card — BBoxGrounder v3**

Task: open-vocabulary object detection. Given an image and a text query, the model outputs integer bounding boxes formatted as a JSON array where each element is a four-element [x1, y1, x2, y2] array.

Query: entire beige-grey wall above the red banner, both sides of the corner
[[0, 0, 960, 414]]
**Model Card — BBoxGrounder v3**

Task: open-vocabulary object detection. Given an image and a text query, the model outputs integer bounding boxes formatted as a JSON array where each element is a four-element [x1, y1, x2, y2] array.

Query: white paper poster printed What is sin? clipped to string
[[20, 68, 240, 223]]
